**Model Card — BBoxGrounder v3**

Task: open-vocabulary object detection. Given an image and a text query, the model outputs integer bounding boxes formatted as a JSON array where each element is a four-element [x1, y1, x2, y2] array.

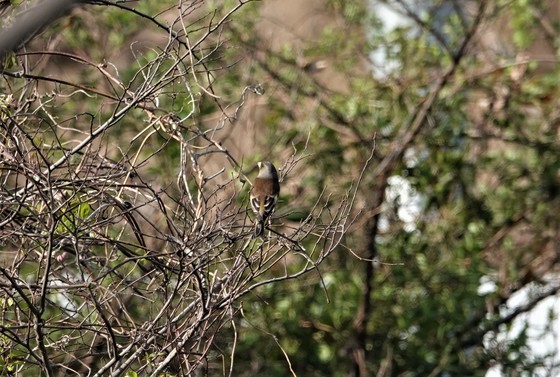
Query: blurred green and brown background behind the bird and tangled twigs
[[0, 0, 560, 377]]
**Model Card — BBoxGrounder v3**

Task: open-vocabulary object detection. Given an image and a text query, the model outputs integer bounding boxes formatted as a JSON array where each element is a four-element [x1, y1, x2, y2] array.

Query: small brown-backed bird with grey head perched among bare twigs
[[249, 161, 280, 238]]
